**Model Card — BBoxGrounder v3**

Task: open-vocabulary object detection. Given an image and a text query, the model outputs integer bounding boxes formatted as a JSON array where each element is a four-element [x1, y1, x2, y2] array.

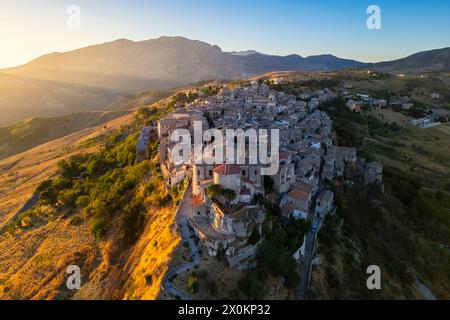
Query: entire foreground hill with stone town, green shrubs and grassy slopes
[[0, 69, 449, 299]]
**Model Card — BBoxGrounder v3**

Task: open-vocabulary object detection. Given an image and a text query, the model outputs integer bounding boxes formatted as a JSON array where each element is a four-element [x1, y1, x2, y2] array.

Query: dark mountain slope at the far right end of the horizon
[[364, 47, 450, 73]]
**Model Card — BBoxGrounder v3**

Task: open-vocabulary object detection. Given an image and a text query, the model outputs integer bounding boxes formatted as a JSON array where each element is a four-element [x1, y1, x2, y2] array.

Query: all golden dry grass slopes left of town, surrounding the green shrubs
[[0, 89, 192, 299]]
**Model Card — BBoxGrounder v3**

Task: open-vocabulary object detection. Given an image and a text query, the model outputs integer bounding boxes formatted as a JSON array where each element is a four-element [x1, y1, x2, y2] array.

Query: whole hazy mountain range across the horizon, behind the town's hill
[[0, 37, 450, 126]]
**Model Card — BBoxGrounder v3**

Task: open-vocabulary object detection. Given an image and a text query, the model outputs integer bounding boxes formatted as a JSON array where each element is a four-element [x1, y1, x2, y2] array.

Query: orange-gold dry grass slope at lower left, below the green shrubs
[[0, 189, 180, 300]]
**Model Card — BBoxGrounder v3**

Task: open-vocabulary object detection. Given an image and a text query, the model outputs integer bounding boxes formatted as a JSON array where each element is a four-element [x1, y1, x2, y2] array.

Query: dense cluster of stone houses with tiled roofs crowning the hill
[[136, 81, 383, 296]]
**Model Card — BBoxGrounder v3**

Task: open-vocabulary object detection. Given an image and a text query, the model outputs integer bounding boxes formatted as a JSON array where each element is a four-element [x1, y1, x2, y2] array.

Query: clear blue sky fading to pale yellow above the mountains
[[0, 0, 450, 67]]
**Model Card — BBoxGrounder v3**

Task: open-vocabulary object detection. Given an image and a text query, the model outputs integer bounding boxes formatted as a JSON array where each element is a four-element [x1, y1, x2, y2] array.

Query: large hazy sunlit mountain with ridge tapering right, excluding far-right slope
[[3, 37, 361, 92]]
